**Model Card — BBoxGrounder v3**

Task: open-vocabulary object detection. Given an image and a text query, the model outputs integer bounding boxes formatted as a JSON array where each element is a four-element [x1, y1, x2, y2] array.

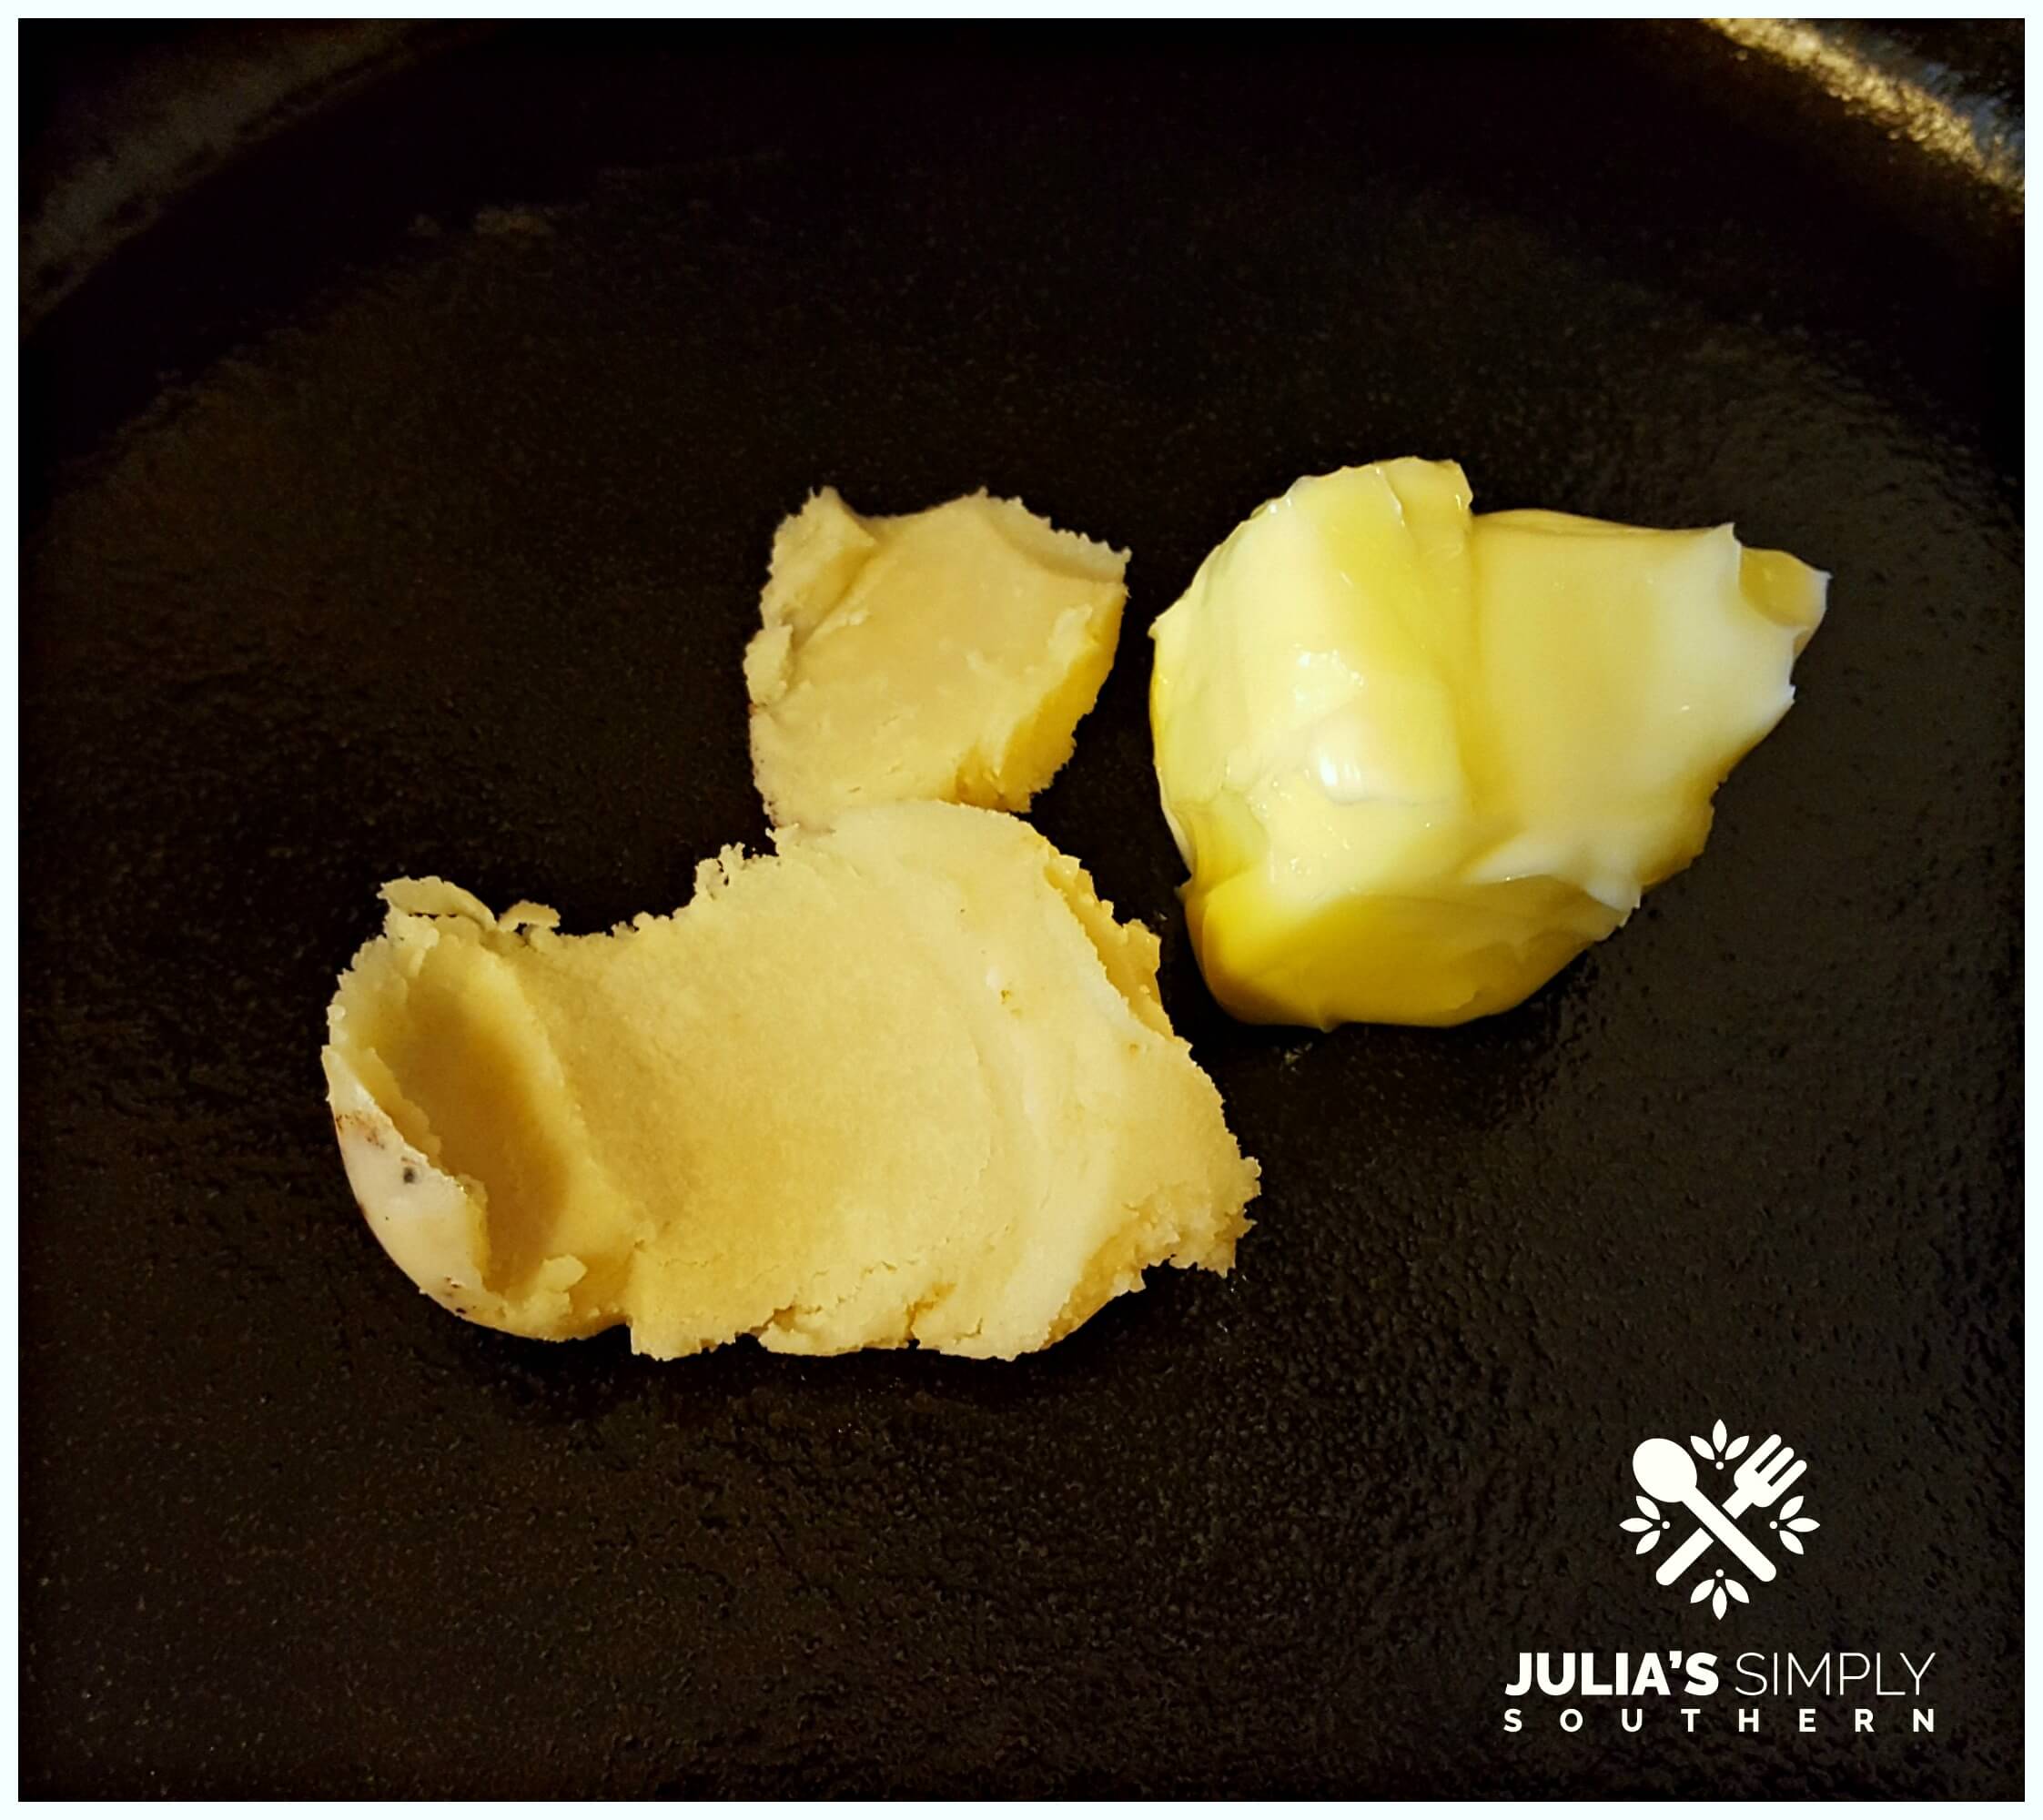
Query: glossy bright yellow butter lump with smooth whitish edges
[[1150, 460, 1826, 1029]]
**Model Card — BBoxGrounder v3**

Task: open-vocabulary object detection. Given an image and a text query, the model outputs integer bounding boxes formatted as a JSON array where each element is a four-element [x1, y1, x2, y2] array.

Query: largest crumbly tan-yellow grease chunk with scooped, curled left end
[[325, 803, 1257, 1359]]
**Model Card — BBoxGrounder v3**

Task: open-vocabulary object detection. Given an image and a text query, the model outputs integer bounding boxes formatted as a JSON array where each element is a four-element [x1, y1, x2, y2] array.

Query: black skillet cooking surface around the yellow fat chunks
[[20, 26, 2023, 1795]]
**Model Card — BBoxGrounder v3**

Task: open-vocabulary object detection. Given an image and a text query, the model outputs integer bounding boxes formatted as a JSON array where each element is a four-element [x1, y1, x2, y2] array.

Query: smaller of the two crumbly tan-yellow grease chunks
[[745, 486, 1128, 827]]
